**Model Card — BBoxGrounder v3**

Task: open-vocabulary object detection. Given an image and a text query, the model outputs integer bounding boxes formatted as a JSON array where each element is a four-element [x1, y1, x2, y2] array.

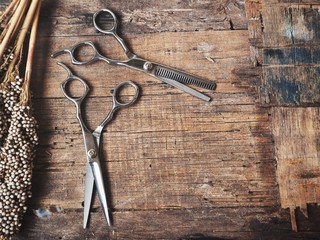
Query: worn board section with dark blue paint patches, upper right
[[260, 6, 320, 106]]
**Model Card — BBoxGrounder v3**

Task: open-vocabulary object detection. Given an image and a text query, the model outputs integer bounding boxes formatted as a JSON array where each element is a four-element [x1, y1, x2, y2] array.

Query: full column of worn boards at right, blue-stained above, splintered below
[[247, 1, 320, 231]]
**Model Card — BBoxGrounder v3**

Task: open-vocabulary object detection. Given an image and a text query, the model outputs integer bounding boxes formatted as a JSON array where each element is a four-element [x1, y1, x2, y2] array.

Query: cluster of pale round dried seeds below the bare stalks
[[0, 71, 38, 240]]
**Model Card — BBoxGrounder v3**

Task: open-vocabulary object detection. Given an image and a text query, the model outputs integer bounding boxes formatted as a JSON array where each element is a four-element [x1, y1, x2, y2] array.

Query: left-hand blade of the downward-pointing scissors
[[83, 163, 94, 229]]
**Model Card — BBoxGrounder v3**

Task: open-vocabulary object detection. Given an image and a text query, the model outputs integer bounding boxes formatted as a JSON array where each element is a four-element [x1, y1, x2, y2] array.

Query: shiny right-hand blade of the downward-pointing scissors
[[89, 160, 111, 226]]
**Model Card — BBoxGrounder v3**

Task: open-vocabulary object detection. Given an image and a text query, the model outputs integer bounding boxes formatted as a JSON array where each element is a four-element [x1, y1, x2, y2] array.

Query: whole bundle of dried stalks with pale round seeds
[[0, 0, 41, 240]]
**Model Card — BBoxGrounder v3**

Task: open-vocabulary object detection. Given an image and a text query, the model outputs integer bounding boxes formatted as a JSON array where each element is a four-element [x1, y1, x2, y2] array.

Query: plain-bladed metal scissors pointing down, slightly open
[[58, 62, 139, 228]]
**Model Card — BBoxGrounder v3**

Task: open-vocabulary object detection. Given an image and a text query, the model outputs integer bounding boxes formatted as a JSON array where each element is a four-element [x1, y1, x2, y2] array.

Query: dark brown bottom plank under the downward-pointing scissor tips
[[18, 206, 319, 240]]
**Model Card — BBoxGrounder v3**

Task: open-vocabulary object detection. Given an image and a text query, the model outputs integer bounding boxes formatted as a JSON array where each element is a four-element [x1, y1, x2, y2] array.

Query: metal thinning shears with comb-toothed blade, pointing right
[[51, 9, 216, 101]]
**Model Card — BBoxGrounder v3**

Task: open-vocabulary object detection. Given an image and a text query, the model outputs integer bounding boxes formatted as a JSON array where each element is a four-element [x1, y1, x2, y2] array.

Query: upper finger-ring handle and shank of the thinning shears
[[93, 9, 135, 58]]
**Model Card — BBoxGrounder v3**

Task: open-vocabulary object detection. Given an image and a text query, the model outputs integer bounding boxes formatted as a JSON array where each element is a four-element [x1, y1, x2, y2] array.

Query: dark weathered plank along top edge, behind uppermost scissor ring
[[39, 0, 247, 39]]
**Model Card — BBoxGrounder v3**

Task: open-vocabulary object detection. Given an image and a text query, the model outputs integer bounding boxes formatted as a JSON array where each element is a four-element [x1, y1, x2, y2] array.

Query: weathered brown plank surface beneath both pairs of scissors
[[0, 0, 320, 239]]
